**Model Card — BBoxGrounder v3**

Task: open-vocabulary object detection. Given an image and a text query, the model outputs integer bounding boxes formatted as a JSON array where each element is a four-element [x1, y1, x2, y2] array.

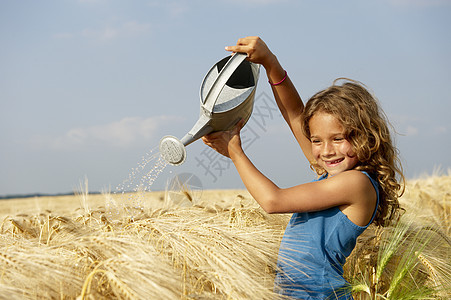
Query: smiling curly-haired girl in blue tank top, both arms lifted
[[203, 37, 404, 299]]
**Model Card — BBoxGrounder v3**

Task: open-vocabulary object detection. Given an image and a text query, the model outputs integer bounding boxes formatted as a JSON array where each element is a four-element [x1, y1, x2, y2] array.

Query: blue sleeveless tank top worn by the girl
[[274, 172, 379, 300]]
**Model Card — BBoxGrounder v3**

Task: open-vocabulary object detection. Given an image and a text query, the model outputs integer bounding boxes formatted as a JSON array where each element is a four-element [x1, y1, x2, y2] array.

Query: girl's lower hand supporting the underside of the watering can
[[202, 120, 244, 158]]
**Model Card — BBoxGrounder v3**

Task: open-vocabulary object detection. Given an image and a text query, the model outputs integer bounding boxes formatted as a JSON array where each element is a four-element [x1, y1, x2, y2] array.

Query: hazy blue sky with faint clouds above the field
[[0, 0, 451, 195]]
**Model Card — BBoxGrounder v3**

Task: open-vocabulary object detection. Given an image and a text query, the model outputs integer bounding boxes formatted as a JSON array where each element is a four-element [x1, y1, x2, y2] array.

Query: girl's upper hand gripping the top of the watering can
[[225, 36, 276, 69]]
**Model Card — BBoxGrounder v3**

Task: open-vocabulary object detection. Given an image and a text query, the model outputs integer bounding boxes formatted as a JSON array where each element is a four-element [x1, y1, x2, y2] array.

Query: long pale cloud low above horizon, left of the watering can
[[30, 116, 181, 150]]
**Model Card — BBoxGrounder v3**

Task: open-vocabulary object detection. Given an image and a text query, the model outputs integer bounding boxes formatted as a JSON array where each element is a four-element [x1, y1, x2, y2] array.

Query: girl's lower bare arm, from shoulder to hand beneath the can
[[202, 121, 376, 226]]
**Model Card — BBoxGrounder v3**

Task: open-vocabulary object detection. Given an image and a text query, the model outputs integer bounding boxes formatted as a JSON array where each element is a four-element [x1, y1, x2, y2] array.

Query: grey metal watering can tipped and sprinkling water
[[159, 53, 260, 166]]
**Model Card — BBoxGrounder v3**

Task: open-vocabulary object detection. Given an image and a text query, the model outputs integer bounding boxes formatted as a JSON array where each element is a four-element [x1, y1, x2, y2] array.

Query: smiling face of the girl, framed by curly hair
[[309, 112, 358, 176]]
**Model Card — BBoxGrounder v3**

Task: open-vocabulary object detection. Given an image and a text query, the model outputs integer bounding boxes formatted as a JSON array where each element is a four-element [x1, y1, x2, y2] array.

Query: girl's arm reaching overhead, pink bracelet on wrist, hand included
[[226, 36, 313, 162]]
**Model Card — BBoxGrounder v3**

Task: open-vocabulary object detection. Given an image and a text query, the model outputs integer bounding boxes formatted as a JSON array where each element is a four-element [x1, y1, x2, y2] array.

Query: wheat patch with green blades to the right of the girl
[[345, 175, 451, 299]]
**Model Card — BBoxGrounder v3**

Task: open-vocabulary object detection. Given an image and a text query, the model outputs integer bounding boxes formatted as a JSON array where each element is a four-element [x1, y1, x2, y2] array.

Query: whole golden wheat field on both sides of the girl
[[0, 172, 451, 299]]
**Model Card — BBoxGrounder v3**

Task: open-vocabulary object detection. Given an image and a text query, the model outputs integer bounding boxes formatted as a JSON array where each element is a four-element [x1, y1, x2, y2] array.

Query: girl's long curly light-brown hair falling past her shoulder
[[303, 78, 405, 226]]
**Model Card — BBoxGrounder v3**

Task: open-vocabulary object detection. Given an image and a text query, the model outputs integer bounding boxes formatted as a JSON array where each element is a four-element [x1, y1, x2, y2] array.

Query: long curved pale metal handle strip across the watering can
[[203, 52, 247, 114]]
